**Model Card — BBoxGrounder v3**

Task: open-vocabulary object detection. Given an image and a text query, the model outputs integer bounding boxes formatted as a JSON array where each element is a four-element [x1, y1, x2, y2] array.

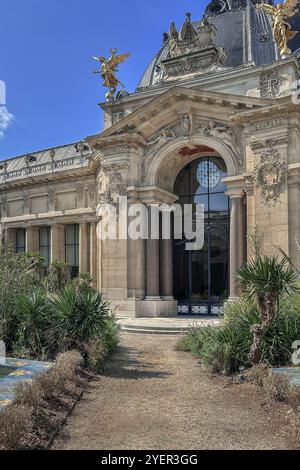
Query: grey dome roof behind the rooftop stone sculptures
[[138, 0, 300, 90]]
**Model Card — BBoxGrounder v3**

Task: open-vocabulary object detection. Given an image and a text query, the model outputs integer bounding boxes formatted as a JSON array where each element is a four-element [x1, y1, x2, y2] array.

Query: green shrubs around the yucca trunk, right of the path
[[180, 293, 300, 373]]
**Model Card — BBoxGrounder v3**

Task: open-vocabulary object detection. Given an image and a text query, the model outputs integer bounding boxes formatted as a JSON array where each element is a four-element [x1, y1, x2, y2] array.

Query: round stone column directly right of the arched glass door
[[228, 192, 246, 298]]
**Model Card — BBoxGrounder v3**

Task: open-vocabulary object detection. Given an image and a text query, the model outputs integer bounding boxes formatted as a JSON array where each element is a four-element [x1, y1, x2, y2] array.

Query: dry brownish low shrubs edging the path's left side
[[0, 351, 82, 449]]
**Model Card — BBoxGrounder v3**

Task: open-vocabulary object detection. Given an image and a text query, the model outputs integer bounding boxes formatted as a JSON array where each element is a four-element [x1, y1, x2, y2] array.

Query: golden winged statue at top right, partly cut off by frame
[[256, 0, 298, 58]]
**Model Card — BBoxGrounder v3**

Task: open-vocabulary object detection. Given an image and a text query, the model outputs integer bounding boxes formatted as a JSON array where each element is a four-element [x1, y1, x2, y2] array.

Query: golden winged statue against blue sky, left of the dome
[[93, 49, 130, 101]]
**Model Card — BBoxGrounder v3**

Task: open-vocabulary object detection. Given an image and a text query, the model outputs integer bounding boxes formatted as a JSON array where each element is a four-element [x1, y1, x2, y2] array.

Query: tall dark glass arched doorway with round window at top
[[173, 156, 230, 315]]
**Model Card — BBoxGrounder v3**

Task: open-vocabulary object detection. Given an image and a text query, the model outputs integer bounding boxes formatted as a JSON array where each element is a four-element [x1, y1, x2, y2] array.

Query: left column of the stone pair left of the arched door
[[146, 205, 161, 300]]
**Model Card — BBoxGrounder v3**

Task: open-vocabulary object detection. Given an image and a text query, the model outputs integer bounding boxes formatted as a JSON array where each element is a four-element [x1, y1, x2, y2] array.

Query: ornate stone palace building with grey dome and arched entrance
[[0, 0, 300, 316]]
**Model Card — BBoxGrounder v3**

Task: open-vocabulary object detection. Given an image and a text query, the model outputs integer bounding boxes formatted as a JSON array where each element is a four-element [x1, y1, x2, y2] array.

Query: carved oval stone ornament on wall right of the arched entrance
[[253, 141, 288, 207]]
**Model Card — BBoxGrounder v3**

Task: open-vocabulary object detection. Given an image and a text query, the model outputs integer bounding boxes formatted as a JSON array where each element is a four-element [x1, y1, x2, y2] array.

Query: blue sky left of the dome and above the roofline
[[0, 0, 209, 159]]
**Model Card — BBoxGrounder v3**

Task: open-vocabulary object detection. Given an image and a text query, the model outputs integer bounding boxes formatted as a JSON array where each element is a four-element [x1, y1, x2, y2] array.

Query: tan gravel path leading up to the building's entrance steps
[[53, 335, 291, 450]]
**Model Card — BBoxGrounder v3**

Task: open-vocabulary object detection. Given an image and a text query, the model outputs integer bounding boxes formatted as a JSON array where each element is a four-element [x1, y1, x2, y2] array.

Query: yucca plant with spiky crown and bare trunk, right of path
[[236, 256, 298, 365]]
